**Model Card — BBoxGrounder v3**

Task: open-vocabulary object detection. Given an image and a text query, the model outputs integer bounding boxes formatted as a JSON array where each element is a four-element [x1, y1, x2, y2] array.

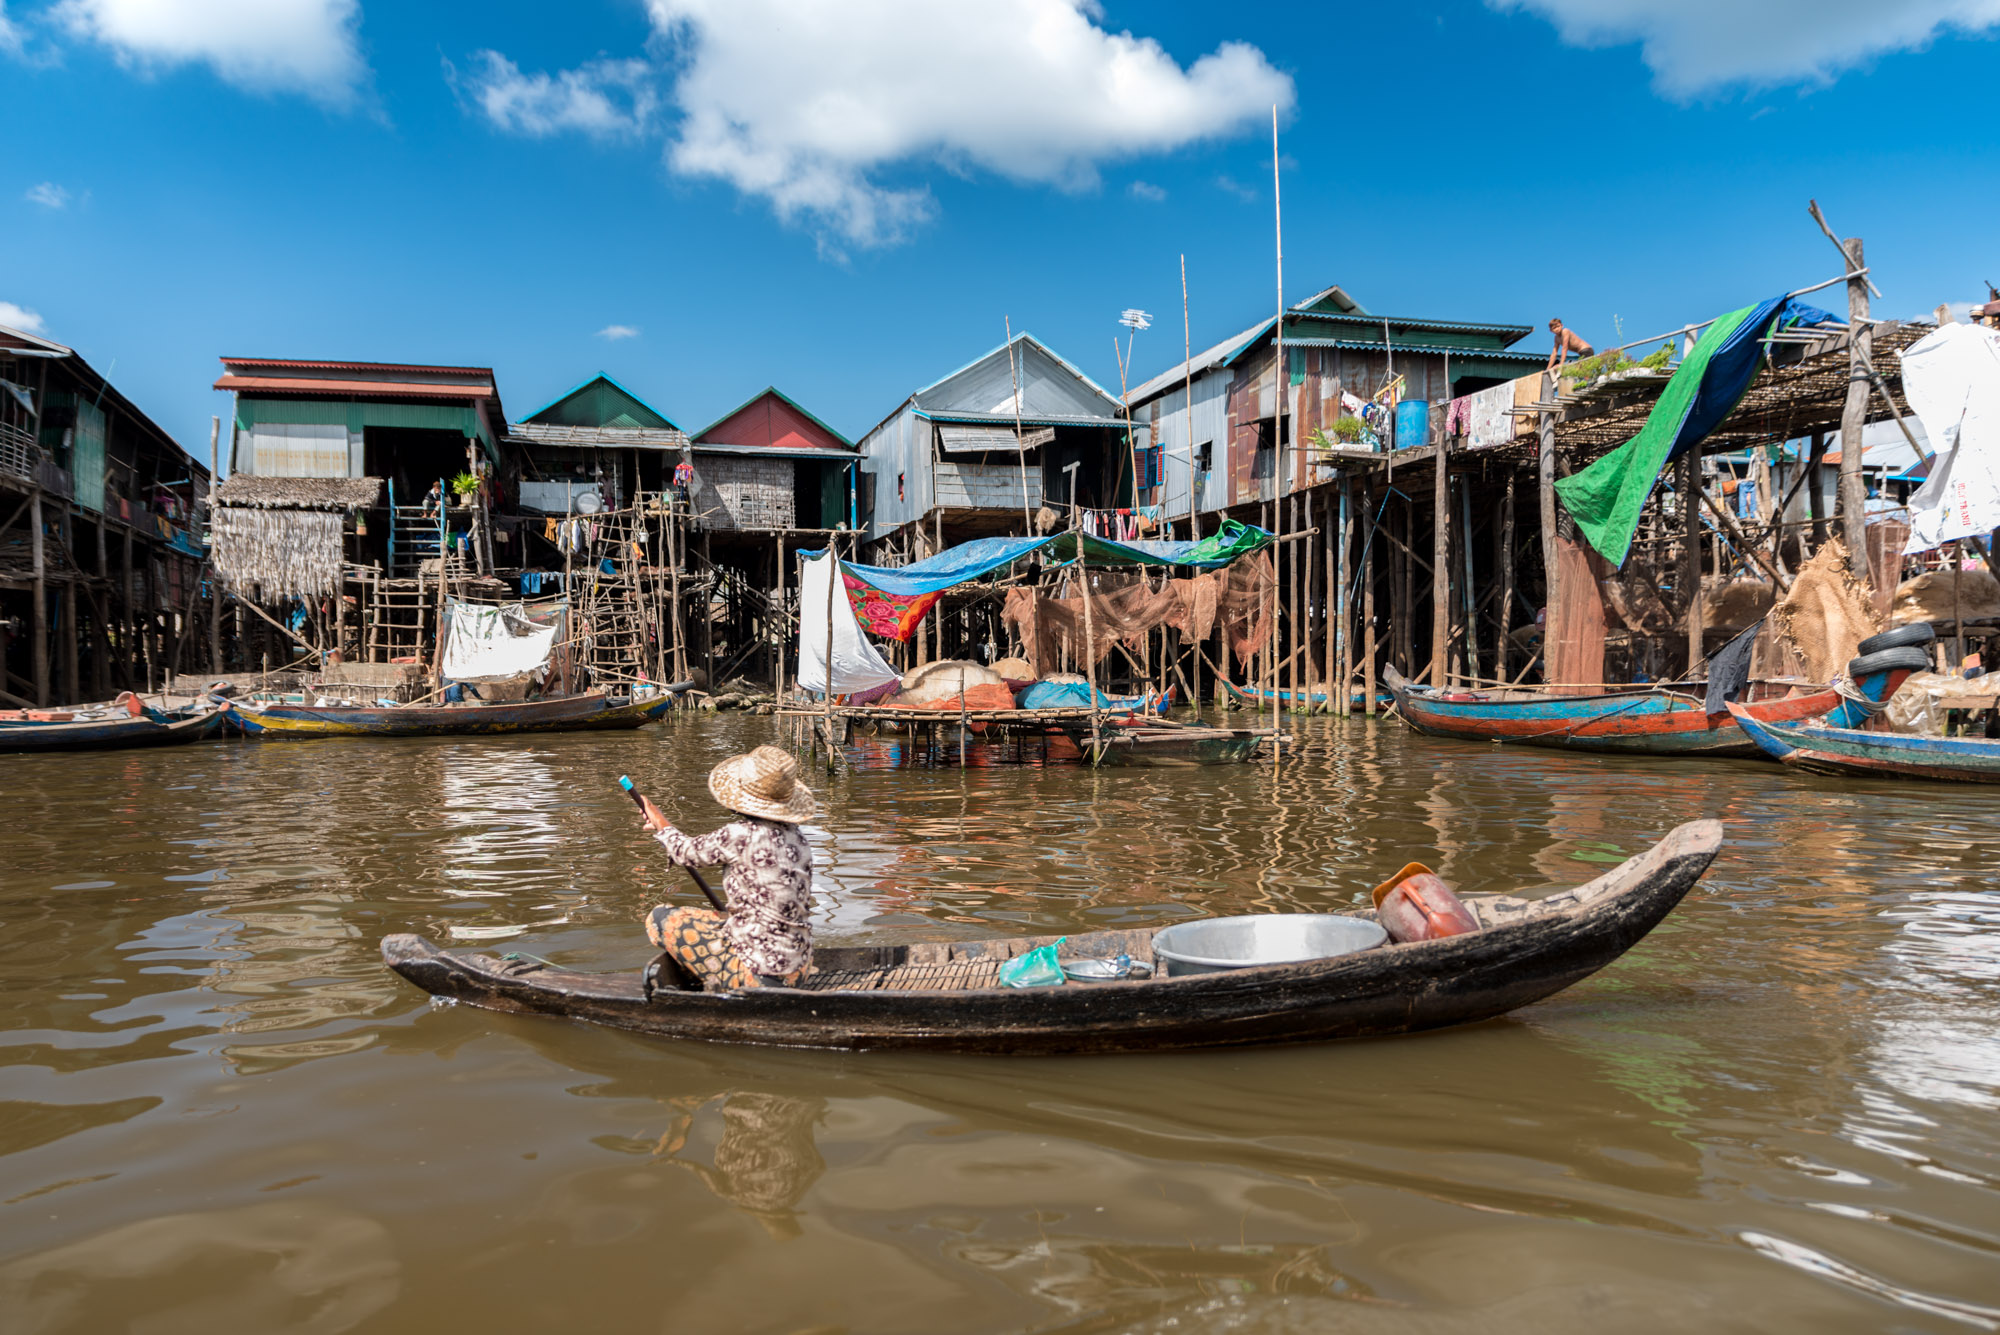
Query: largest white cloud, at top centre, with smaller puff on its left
[[460, 0, 1294, 246]]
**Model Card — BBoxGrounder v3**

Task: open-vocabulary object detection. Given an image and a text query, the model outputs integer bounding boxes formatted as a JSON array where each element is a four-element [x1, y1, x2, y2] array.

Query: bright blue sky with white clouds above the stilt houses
[[0, 0, 2000, 463]]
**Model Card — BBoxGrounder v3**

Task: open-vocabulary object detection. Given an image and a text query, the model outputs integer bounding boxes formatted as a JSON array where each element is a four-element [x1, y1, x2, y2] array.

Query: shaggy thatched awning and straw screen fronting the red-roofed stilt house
[[212, 476, 382, 602]]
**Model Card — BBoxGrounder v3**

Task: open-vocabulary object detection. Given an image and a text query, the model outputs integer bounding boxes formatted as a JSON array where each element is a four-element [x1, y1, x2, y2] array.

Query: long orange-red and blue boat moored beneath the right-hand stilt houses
[[1382, 668, 1856, 759]]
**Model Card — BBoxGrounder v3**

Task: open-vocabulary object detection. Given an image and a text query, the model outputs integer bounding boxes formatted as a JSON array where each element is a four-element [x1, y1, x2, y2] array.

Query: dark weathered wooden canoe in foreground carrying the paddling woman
[[382, 821, 1722, 1053]]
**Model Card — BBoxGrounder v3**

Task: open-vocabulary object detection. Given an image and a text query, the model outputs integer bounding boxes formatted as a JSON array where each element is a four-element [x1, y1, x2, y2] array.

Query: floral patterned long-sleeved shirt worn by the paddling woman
[[654, 815, 812, 975]]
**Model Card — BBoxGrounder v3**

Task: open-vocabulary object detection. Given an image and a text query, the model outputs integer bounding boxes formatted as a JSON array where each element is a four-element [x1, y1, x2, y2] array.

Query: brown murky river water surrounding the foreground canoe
[[0, 717, 2000, 1335]]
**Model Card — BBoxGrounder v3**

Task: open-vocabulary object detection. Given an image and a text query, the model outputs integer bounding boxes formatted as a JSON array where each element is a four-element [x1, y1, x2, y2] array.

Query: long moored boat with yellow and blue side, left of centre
[[230, 693, 674, 739]]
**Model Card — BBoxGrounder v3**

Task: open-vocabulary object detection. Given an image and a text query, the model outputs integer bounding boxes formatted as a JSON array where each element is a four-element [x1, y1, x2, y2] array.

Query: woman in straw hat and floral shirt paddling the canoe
[[628, 745, 812, 991]]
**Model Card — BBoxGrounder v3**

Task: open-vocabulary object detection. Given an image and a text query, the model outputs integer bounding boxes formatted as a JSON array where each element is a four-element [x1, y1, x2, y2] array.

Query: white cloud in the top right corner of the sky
[[1486, 0, 2000, 98]]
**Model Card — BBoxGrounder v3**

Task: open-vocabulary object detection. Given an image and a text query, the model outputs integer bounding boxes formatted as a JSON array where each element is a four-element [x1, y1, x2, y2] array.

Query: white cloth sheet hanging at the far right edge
[[1902, 324, 2000, 552]]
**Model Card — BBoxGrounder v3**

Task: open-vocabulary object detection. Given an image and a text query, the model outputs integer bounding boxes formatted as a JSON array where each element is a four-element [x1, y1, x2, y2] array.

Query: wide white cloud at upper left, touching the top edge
[[50, 0, 368, 106]]
